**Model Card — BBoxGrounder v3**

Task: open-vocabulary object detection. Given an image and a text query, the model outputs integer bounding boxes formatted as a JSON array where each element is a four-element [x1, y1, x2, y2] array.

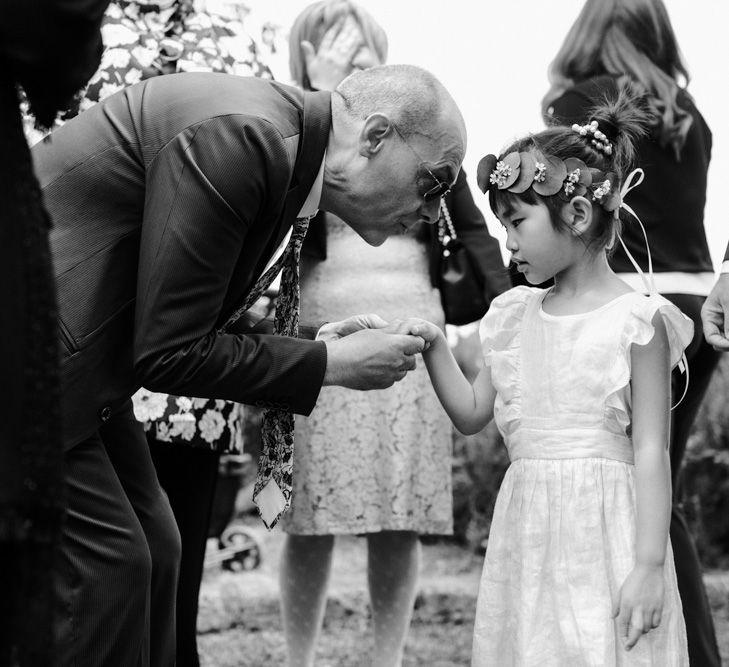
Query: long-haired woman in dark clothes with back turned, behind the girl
[[542, 0, 720, 667]]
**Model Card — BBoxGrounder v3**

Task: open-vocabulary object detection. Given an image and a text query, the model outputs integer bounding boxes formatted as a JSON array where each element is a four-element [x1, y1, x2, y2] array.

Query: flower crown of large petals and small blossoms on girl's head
[[477, 150, 621, 211]]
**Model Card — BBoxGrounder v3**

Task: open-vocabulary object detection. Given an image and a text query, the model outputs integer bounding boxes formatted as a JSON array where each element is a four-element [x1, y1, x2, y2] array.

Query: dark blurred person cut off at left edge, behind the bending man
[[0, 0, 108, 667]]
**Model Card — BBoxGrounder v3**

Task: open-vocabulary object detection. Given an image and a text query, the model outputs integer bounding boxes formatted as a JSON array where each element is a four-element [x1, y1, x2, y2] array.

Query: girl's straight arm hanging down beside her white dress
[[614, 313, 671, 650]]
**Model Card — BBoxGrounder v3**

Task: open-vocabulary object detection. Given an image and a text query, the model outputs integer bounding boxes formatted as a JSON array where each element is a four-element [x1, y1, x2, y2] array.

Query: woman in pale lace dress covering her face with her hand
[[280, 0, 508, 667]]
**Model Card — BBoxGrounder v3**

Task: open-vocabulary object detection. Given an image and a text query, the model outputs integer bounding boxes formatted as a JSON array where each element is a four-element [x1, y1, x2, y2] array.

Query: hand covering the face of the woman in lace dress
[[301, 15, 364, 90]]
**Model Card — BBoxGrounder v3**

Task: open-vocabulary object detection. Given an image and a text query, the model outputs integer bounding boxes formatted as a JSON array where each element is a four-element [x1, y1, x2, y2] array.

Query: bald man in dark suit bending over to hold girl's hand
[[33, 66, 465, 667]]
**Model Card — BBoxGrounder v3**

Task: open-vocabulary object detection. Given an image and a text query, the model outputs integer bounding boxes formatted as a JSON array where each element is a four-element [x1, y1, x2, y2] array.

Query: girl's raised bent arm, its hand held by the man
[[410, 320, 496, 435]]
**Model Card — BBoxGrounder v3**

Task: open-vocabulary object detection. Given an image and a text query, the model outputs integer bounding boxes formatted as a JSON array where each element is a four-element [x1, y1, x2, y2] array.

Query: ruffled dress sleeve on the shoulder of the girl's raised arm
[[478, 285, 539, 366]]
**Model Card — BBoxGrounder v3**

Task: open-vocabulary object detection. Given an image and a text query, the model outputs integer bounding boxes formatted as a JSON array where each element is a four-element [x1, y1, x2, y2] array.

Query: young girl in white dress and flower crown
[[406, 96, 693, 667]]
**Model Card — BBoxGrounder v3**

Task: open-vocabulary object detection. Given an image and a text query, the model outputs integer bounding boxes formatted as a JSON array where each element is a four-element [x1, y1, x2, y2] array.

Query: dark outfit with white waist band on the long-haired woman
[[547, 76, 721, 667]]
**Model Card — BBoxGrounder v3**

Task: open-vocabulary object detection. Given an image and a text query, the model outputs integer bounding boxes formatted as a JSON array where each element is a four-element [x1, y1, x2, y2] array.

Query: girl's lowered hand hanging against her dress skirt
[[613, 565, 663, 651]]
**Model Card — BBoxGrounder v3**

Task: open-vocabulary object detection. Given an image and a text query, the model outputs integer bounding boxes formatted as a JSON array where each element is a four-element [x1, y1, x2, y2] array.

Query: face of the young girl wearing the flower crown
[[497, 199, 575, 285]]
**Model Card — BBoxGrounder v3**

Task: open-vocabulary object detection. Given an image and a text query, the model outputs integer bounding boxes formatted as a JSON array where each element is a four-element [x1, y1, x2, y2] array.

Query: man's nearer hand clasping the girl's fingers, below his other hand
[[324, 329, 425, 389]]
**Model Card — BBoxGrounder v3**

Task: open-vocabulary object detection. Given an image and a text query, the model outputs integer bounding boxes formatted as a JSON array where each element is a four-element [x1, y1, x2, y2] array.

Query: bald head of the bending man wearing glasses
[[320, 65, 466, 245]]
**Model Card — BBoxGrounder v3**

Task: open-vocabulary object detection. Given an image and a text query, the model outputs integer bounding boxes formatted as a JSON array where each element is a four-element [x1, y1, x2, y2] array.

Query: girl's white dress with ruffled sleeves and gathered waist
[[472, 287, 693, 667]]
